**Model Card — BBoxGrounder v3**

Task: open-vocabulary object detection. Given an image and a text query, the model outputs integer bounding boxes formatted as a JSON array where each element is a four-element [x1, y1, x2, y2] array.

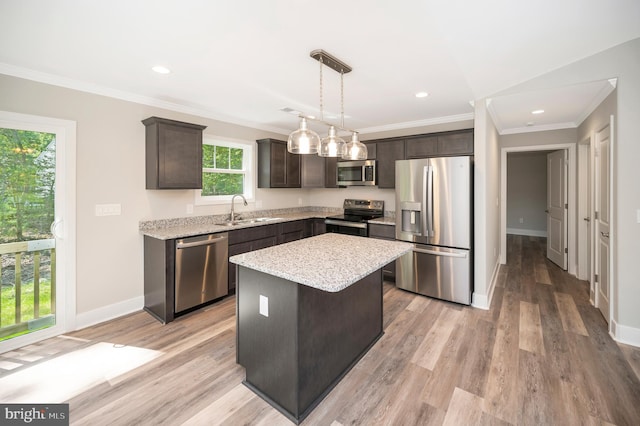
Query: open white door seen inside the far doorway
[[547, 149, 568, 270]]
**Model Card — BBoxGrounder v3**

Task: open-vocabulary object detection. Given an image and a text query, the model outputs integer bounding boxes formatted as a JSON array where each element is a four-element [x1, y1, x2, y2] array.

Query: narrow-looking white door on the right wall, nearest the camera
[[595, 125, 611, 323]]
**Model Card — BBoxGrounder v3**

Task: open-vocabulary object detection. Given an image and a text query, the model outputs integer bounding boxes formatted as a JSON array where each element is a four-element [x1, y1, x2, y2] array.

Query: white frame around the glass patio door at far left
[[0, 111, 76, 353]]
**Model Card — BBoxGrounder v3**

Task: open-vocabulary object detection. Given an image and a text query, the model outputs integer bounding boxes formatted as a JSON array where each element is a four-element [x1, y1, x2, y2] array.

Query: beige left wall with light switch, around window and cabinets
[[0, 75, 292, 315]]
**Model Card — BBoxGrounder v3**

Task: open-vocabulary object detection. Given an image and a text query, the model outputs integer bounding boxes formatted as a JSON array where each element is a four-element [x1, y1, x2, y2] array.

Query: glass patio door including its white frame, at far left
[[0, 111, 75, 353]]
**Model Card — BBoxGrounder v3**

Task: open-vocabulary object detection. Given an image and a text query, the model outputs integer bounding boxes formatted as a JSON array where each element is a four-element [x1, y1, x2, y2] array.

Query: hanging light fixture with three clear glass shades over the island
[[287, 49, 367, 160]]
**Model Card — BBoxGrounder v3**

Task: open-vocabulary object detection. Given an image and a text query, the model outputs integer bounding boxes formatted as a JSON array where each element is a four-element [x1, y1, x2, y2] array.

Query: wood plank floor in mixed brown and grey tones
[[0, 236, 640, 426]]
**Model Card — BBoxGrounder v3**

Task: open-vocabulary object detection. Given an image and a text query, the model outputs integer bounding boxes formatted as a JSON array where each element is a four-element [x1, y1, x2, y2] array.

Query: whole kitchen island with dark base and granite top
[[230, 234, 412, 423]]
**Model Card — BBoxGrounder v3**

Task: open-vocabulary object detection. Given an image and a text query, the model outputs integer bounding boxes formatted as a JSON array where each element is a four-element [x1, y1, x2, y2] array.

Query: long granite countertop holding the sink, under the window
[[140, 211, 335, 240]]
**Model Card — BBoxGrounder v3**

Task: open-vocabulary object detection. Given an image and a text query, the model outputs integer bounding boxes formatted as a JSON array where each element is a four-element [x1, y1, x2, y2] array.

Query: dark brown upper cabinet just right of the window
[[257, 139, 301, 188]]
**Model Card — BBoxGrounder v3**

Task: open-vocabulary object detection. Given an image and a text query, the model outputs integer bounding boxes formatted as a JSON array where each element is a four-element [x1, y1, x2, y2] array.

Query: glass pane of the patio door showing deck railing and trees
[[0, 128, 56, 341]]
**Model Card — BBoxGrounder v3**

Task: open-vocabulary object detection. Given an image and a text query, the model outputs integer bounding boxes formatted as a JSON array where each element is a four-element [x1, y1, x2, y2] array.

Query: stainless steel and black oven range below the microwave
[[324, 198, 384, 237]]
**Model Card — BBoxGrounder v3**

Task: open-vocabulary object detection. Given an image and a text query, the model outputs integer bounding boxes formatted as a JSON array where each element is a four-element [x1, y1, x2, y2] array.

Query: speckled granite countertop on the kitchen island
[[229, 233, 413, 292]]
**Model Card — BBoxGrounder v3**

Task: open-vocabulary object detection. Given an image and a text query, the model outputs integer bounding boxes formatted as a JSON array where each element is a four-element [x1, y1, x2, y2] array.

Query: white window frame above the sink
[[195, 135, 256, 206]]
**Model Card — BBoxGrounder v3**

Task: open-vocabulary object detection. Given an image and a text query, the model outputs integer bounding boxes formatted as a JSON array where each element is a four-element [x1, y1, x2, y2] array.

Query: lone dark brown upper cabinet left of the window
[[142, 117, 207, 189]]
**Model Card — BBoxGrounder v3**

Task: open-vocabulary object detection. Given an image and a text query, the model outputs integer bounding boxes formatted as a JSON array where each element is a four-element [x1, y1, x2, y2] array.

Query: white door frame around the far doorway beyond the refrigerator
[[500, 143, 577, 275]]
